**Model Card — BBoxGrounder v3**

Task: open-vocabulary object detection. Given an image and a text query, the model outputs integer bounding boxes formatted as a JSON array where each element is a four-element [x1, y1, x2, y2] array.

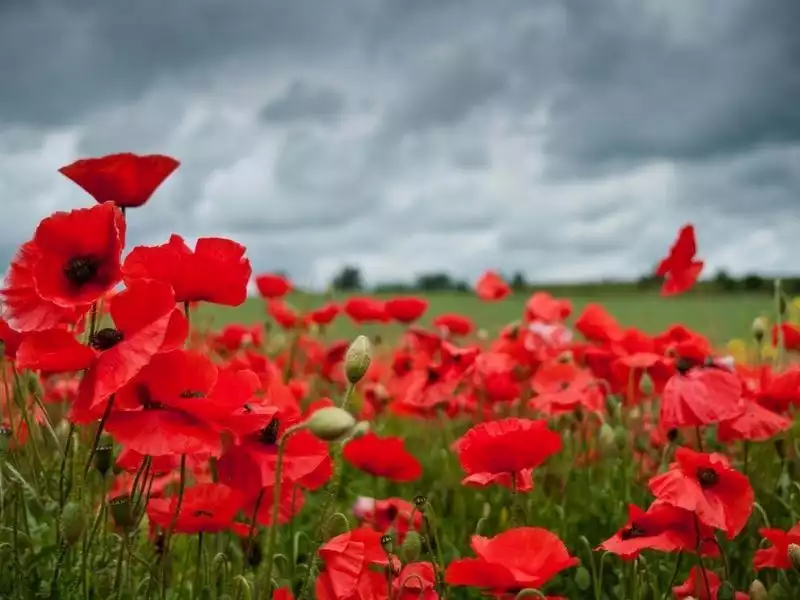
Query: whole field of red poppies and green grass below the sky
[[0, 154, 800, 600]]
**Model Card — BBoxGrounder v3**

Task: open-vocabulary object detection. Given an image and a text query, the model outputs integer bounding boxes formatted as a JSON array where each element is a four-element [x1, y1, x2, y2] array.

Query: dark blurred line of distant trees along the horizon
[[330, 265, 800, 295]]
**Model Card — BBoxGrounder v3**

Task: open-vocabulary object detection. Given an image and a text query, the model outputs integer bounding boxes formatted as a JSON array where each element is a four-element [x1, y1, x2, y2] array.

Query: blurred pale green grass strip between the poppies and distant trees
[[197, 293, 772, 343]]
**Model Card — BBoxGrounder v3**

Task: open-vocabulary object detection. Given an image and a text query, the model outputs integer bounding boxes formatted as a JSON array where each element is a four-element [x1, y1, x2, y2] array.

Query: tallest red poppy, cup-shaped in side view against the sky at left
[[58, 152, 180, 208]]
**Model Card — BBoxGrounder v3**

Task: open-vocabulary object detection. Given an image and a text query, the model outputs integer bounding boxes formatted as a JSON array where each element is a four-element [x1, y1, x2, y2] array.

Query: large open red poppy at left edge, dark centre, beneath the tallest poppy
[[0, 204, 125, 332]]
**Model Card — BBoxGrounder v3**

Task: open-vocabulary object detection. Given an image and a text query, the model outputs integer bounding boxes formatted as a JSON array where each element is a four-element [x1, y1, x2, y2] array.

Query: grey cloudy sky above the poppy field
[[0, 0, 800, 285]]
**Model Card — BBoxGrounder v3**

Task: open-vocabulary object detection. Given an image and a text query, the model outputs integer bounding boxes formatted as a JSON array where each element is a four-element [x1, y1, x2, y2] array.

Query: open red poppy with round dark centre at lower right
[[649, 448, 755, 539]]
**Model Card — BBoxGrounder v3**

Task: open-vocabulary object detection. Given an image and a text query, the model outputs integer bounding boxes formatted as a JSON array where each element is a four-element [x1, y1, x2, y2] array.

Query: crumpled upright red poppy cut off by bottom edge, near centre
[[315, 527, 397, 600]]
